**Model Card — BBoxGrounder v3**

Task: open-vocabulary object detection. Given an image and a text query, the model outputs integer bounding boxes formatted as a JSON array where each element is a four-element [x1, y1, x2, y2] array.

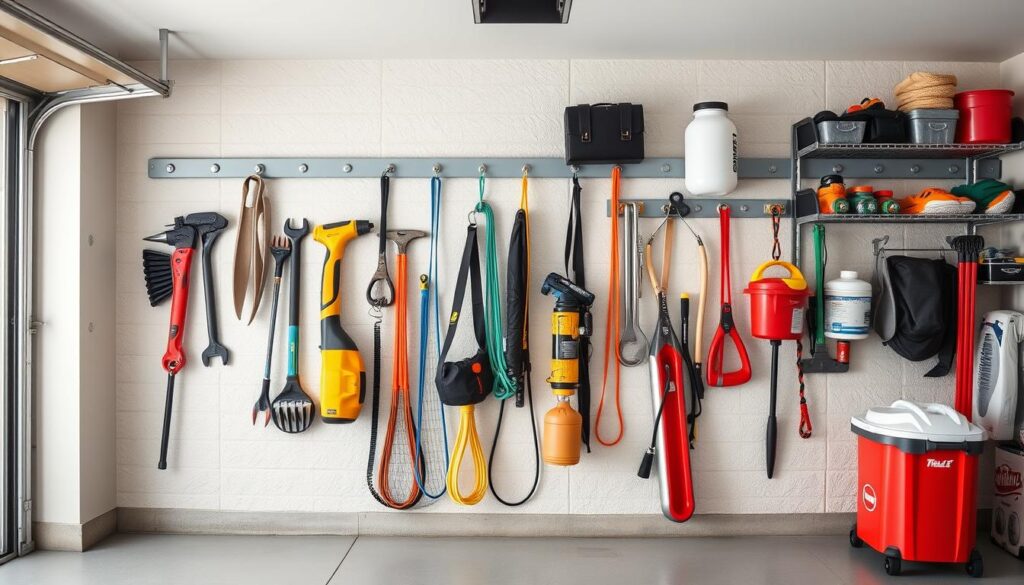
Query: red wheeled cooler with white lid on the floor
[[850, 401, 985, 577]]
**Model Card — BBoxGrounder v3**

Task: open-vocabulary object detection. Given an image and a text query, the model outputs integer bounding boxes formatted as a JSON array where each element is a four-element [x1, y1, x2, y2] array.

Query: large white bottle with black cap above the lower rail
[[685, 101, 739, 197]]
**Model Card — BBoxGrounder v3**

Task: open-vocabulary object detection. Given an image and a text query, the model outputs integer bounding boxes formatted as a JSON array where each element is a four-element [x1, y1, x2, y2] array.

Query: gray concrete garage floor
[[0, 534, 1024, 585]]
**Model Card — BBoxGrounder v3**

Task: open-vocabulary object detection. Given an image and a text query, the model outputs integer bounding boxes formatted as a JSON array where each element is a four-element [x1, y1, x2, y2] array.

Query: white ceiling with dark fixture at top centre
[[20, 0, 1024, 61]]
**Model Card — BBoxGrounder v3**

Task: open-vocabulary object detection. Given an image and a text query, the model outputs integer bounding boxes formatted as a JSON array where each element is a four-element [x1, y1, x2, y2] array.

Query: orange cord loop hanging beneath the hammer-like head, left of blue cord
[[377, 254, 420, 510]]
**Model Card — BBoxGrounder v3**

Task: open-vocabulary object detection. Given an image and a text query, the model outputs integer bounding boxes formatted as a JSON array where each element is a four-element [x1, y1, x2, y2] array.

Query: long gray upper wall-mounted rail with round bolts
[[148, 157, 1001, 179]]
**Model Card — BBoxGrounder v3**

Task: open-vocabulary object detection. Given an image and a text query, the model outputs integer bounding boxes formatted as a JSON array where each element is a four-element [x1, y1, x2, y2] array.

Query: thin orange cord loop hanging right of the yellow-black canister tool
[[594, 166, 626, 447]]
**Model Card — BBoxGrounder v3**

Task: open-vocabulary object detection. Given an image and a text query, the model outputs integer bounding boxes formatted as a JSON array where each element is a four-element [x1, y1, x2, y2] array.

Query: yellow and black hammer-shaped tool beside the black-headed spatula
[[313, 219, 374, 424]]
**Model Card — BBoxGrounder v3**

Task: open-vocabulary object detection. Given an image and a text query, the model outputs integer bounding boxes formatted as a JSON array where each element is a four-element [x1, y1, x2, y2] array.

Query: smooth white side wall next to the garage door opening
[[34, 103, 117, 525]]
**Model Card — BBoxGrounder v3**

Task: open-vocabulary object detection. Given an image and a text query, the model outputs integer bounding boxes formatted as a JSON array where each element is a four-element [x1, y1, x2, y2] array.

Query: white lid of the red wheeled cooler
[[850, 401, 985, 443]]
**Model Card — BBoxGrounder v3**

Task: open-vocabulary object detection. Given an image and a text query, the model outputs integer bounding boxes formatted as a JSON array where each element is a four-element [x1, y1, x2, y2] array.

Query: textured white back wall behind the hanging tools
[[117, 60, 999, 513]]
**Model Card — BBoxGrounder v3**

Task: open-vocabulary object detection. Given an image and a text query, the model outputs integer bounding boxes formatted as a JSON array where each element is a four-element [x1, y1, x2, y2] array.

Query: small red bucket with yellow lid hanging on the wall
[[743, 260, 811, 340]]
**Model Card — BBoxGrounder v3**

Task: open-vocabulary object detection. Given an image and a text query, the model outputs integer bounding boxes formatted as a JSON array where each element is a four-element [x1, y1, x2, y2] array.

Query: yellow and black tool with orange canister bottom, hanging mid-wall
[[541, 273, 594, 465]]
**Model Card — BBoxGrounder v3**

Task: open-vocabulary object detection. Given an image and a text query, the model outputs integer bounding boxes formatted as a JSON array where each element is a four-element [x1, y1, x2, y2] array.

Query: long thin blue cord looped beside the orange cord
[[414, 176, 451, 499]]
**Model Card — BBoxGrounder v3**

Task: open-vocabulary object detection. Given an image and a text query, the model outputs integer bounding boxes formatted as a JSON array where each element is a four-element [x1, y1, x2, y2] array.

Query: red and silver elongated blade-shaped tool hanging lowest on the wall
[[657, 343, 695, 523]]
